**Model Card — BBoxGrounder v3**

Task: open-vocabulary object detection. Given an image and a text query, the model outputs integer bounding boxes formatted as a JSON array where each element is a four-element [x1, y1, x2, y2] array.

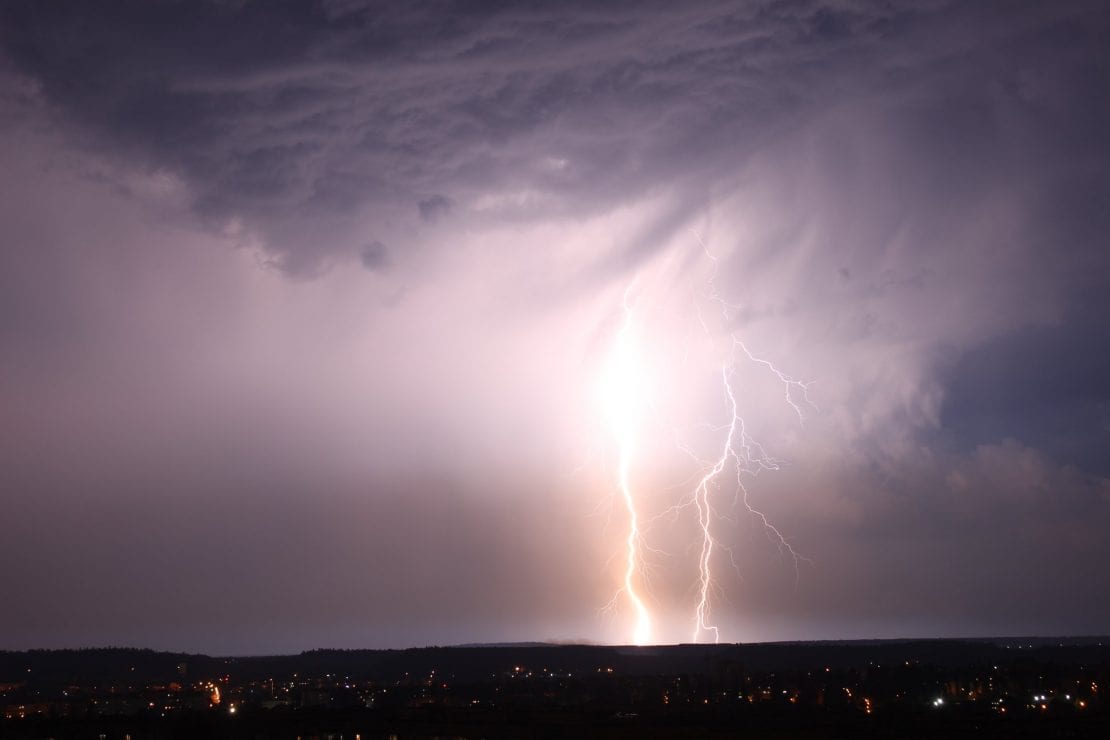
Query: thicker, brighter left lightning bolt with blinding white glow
[[603, 283, 652, 645]]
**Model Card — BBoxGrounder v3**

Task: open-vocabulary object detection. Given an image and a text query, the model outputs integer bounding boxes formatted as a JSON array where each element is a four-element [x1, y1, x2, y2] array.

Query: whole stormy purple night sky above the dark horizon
[[0, 0, 1110, 653]]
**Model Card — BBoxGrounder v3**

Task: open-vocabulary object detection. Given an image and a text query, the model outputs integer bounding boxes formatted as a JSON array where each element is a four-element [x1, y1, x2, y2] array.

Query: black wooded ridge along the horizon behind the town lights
[[0, 638, 1110, 683]]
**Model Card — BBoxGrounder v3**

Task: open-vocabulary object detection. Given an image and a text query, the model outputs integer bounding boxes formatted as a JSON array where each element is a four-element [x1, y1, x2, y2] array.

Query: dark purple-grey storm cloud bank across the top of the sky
[[2, 2, 1106, 275]]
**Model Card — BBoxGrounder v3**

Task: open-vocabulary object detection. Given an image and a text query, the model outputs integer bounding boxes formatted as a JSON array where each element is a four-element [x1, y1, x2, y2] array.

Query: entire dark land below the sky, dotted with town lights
[[0, 638, 1110, 740]]
